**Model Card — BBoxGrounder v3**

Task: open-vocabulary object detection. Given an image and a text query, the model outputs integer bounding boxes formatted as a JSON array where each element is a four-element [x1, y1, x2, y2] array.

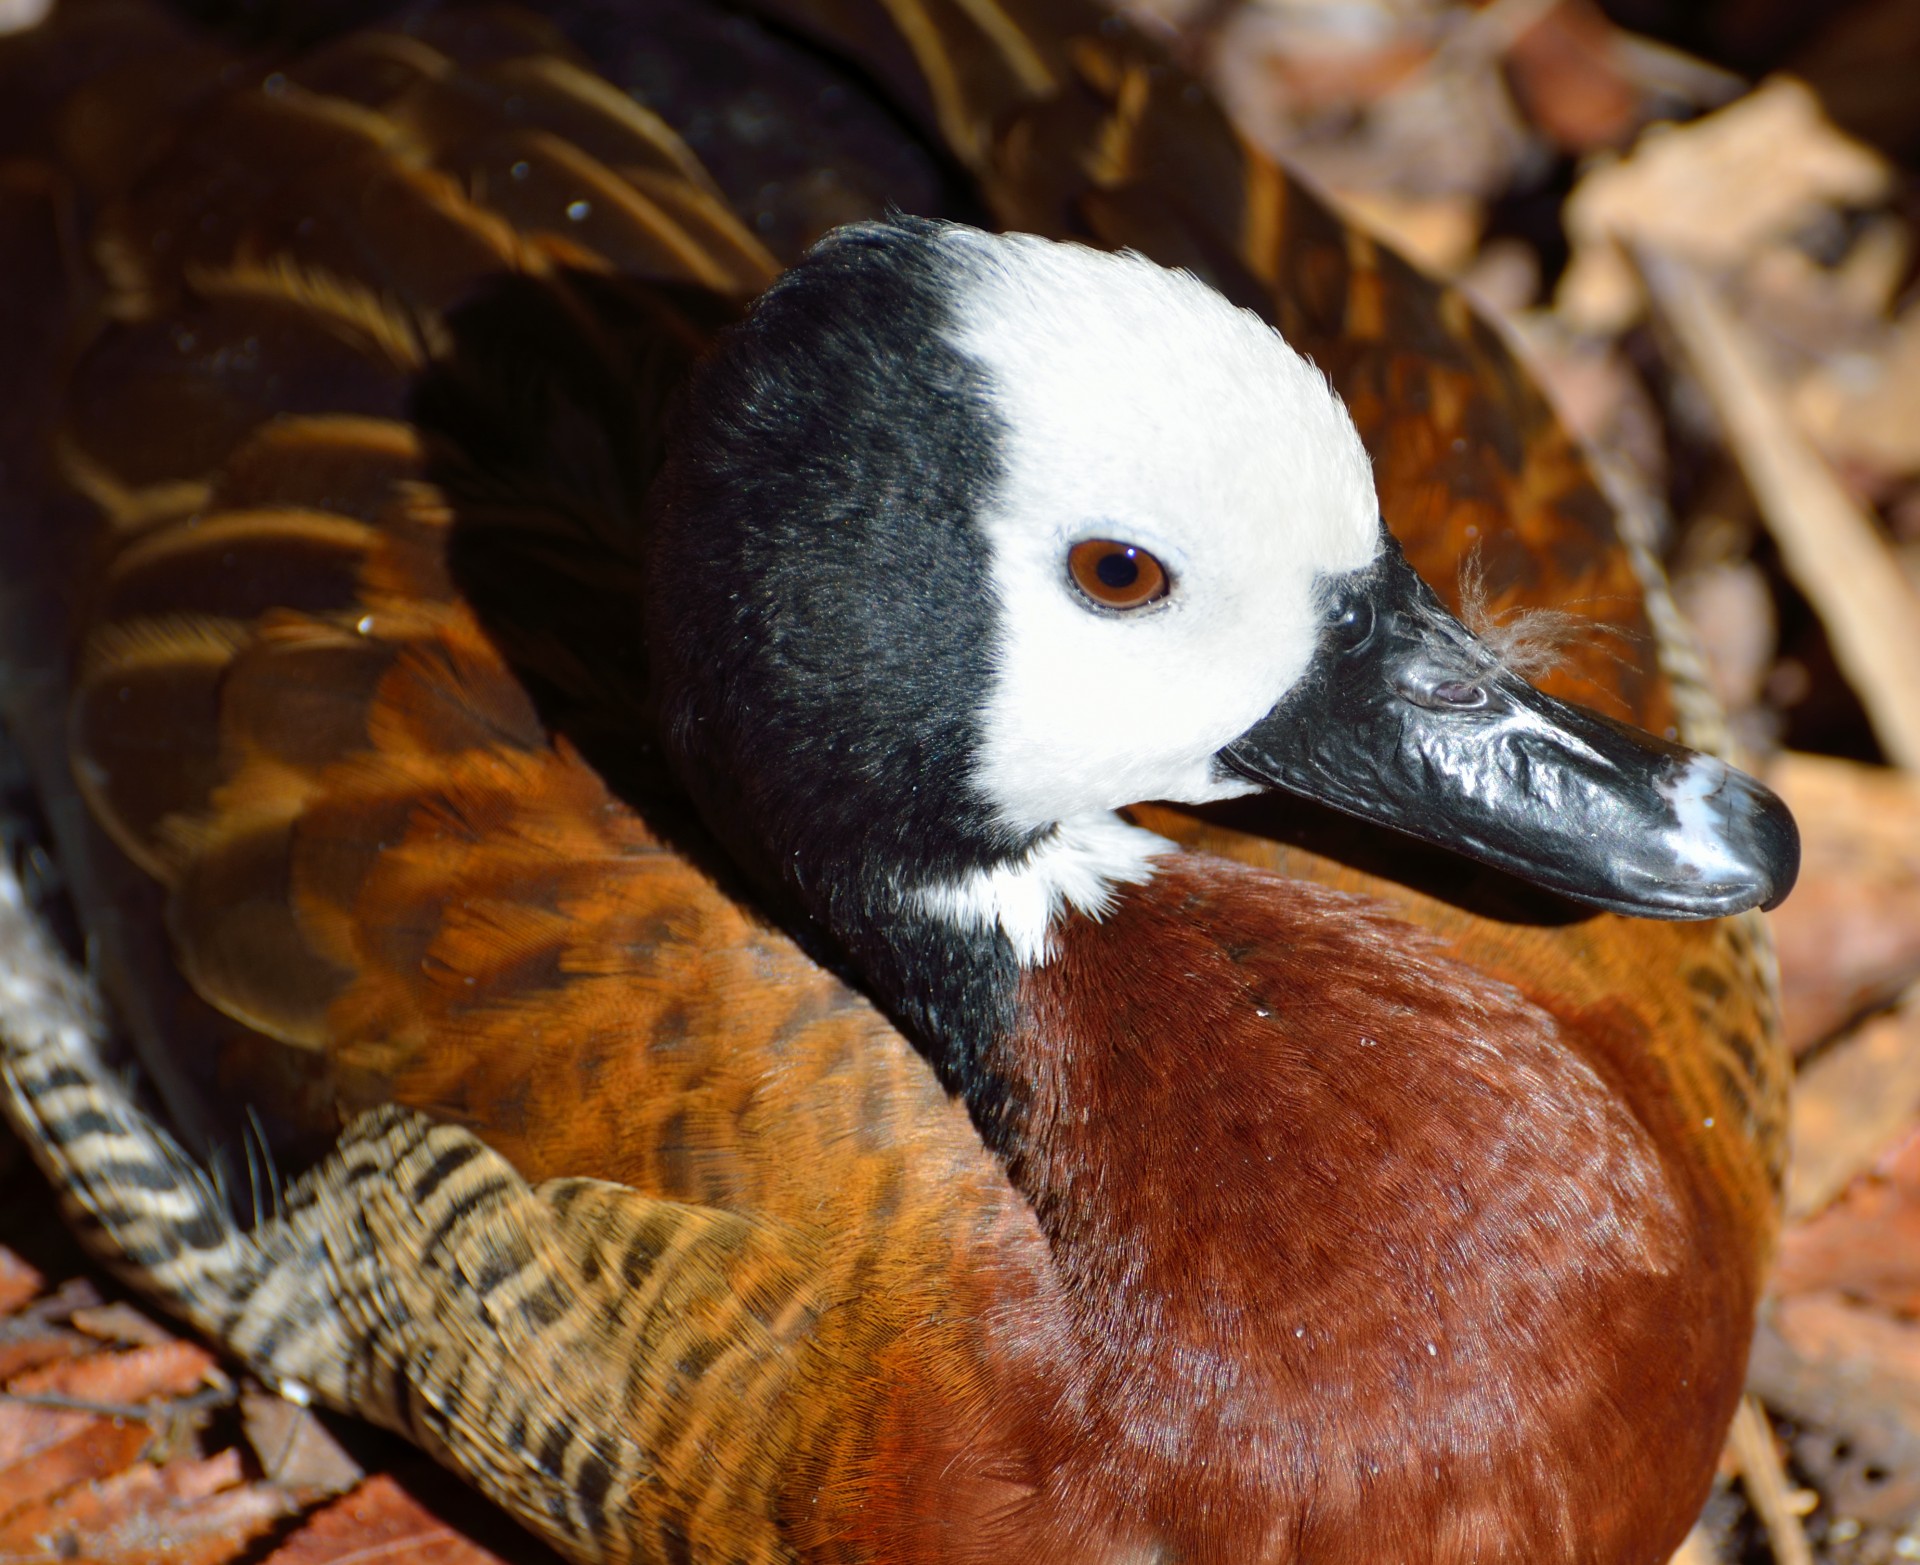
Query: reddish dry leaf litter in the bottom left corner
[[0, 1236, 553, 1565]]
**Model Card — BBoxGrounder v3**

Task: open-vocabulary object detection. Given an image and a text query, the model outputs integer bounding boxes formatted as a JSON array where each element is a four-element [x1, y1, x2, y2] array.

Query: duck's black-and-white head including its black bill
[[649, 219, 1799, 979]]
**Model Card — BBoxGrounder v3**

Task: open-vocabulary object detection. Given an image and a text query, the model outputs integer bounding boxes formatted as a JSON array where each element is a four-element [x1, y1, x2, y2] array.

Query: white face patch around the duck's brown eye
[[945, 229, 1379, 831]]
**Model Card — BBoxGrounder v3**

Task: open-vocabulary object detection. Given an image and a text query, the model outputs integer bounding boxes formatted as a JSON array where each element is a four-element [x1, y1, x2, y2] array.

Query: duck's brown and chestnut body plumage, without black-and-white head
[[0, 0, 1784, 1565]]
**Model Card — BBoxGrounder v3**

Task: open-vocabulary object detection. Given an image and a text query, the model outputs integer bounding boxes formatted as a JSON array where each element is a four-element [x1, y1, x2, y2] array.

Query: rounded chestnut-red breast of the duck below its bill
[[1010, 860, 1751, 1561]]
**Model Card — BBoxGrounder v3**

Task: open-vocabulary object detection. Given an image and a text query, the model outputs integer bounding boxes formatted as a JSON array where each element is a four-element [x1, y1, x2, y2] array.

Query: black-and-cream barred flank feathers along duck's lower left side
[[0, 844, 818, 1563]]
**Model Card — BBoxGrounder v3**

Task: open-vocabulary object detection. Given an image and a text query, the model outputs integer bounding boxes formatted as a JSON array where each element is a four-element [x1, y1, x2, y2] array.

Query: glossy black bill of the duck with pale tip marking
[[1221, 538, 1799, 918]]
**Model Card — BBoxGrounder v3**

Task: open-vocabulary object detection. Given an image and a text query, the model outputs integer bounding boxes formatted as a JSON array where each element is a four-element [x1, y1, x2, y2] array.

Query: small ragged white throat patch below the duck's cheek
[[912, 812, 1179, 968]]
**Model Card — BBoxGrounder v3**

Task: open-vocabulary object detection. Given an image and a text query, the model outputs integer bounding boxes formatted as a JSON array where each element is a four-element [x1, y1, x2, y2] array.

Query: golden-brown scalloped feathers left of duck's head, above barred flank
[[0, 0, 985, 1236]]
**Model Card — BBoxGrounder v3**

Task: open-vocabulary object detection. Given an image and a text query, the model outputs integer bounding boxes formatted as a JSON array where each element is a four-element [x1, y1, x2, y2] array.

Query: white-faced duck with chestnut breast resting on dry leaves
[[0, 0, 1797, 1565]]
